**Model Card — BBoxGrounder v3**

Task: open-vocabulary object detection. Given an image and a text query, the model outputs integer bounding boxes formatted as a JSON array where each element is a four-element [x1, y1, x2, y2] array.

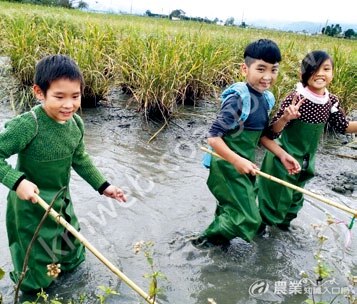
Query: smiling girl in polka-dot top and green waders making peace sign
[[258, 51, 357, 230]]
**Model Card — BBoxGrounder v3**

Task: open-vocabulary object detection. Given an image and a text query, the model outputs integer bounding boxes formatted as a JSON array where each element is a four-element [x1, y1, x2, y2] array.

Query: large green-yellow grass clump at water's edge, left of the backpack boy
[[117, 32, 237, 114]]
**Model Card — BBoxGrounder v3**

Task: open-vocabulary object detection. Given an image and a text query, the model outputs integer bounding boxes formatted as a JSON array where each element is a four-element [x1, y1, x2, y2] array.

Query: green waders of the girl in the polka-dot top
[[257, 120, 325, 227]]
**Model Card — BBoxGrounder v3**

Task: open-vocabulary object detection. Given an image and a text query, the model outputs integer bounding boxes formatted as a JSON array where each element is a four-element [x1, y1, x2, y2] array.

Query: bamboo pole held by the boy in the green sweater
[[37, 195, 156, 304]]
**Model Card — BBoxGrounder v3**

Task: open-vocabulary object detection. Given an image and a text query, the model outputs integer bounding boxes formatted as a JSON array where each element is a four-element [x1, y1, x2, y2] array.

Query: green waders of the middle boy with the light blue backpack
[[203, 130, 261, 242]]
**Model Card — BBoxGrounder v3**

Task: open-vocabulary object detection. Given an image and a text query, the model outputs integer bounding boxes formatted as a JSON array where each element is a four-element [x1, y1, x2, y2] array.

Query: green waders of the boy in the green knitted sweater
[[6, 153, 85, 291]]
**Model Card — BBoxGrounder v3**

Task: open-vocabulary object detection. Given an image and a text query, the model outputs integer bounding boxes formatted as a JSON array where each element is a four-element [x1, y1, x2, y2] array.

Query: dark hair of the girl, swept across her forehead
[[301, 51, 333, 87]]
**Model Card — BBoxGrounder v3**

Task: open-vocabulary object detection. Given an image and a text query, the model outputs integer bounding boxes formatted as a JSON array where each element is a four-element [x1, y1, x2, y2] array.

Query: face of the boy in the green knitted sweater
[[33, 78, 81, 123]]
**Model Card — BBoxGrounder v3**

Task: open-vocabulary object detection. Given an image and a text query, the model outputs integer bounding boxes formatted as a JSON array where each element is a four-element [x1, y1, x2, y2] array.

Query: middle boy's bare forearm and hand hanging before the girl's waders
[[260, 136, 301, 174]]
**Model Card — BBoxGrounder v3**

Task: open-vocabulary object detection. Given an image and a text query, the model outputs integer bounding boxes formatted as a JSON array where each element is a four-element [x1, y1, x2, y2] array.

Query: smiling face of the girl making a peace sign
[[307, 59, 333, 95]]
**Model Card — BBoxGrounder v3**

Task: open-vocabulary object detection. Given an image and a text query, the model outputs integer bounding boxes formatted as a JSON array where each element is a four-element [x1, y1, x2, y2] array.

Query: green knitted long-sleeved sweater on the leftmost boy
[[0, 105, 106, 190]]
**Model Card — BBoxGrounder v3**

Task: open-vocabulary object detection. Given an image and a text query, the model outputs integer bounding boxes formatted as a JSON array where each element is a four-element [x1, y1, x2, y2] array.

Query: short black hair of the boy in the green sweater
[[34, 54, 84, 95]]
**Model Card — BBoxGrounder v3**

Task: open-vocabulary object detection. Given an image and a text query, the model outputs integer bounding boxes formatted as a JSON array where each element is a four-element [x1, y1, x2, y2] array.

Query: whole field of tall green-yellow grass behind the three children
[[0, 2, 357, 116]]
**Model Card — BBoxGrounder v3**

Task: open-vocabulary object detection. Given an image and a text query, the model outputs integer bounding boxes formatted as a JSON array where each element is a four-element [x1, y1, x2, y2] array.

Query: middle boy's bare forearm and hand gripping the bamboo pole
[[208, 137, 258, 175]]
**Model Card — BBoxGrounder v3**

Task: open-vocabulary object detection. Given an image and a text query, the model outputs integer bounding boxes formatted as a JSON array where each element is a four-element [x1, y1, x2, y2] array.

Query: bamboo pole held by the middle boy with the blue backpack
[[201, 147, 357, 218]]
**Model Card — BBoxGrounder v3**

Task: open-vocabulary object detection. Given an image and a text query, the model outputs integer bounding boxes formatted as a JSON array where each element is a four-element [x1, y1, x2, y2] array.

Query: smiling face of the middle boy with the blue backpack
[[242, 59, 279, 93]]
